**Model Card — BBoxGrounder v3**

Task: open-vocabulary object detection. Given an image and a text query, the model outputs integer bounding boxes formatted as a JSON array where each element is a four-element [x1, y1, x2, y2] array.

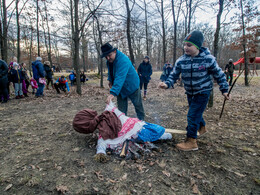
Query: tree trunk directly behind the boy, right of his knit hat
[[208, 0, 224, 108]]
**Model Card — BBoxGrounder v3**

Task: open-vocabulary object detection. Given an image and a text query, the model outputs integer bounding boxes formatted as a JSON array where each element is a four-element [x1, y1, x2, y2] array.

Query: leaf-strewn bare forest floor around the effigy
[[0, 73, 260, 195]]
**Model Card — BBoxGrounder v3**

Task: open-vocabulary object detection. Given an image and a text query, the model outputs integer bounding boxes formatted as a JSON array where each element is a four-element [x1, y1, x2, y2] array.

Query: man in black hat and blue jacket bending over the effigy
[[101, 43, 145, 120]]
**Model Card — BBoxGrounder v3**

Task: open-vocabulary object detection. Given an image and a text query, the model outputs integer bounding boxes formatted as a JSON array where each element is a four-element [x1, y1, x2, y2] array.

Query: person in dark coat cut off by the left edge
[[0, 60, 8, 103]]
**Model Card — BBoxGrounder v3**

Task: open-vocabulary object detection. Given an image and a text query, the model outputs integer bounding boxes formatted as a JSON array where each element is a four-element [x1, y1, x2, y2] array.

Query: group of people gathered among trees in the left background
[[0, 57, 87, 103]]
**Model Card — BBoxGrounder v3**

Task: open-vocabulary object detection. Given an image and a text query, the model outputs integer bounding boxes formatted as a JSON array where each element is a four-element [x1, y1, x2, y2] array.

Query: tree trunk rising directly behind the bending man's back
[[125, 0, 135, 66]]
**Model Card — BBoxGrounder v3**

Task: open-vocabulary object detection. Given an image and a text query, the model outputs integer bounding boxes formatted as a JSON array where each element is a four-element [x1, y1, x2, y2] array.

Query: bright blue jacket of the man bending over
[[107, 50, 140, 99]]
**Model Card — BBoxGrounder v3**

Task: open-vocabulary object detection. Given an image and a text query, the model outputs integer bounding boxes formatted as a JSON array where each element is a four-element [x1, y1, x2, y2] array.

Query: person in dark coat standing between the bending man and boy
[[137, 56, 153, 100]]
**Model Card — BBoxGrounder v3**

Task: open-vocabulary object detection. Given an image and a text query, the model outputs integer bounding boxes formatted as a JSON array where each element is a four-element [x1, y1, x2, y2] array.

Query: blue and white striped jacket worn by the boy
[[165, 47, 228, 95]]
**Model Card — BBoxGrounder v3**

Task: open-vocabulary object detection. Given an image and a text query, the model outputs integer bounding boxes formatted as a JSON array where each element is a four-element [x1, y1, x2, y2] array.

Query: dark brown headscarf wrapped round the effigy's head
[[73, 109, 122, 140]]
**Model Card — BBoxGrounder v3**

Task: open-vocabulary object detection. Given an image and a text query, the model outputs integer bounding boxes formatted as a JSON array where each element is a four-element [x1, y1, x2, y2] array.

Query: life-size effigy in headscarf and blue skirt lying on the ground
[[73, 101, 172, 162]]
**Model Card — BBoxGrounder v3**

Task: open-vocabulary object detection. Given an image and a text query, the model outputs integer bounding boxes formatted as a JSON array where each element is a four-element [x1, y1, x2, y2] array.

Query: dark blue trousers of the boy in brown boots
[[186, 91, 210, 139]]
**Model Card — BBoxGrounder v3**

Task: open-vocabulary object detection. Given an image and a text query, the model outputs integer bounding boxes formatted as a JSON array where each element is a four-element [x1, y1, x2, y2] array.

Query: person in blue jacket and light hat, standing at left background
[[32, 57, 45, 97]]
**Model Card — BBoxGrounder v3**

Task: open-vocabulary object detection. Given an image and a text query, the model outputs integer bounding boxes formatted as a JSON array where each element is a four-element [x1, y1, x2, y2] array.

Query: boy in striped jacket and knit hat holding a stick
[[158, 30, 230, 151]]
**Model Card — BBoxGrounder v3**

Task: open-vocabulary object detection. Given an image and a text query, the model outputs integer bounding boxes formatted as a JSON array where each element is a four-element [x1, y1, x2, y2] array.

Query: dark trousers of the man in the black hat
[[117, 89, 145, 120]]
